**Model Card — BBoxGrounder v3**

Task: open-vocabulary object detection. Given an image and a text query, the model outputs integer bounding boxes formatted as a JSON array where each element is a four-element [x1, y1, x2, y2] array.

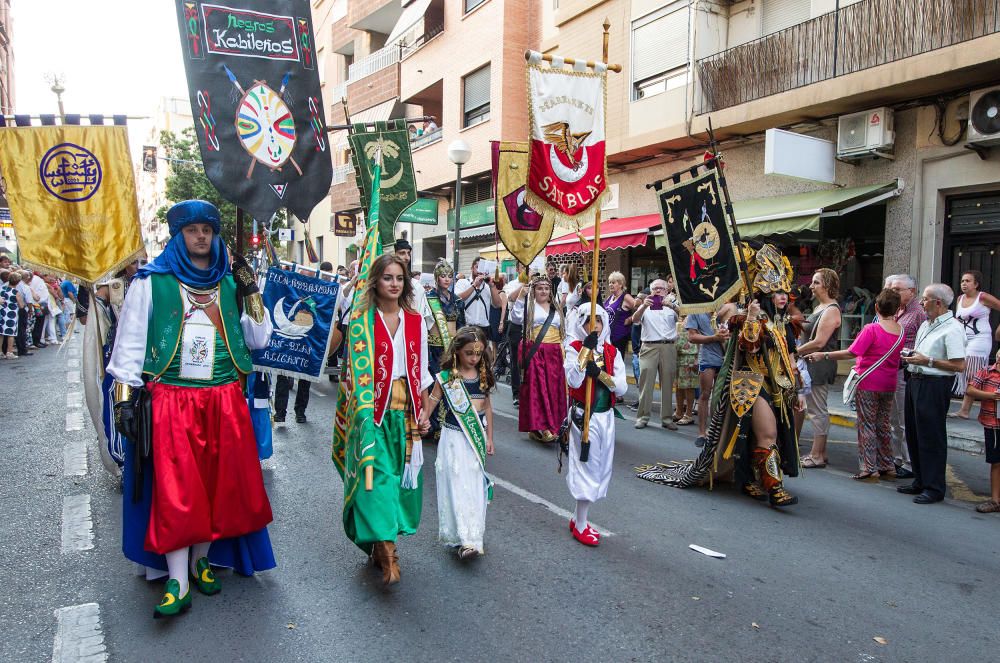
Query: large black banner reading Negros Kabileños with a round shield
[[177, 0, 333, 222]]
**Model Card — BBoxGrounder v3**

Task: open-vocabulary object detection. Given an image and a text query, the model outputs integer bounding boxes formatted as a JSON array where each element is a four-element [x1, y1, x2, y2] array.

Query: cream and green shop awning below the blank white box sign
[[733, 180, 903, 239]]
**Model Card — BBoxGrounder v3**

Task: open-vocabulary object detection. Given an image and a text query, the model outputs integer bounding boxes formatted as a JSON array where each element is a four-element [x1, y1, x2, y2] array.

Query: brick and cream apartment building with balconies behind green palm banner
[[309, 0, 542, 271]]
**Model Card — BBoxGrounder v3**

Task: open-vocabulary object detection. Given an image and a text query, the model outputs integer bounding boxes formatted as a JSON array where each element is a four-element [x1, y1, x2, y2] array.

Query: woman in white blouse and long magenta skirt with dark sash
[[510, 274, 567, 442]]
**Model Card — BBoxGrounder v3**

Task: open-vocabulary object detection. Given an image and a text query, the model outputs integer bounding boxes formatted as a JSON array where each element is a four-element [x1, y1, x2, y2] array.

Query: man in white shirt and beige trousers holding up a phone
[[632, 279, 677, 430]]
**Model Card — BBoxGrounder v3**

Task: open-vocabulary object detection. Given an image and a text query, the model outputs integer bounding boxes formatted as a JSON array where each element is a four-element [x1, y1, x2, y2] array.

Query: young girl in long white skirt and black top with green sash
[[423, 327, 496, 559]]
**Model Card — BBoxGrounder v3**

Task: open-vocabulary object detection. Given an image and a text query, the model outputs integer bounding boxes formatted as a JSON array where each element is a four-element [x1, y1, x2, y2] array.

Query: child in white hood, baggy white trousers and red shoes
[[563, 303, 628, 546]]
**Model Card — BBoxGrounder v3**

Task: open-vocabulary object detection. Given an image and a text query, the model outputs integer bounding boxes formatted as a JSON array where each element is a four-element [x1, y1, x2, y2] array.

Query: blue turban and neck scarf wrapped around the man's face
[[136, 200, 230, 288]]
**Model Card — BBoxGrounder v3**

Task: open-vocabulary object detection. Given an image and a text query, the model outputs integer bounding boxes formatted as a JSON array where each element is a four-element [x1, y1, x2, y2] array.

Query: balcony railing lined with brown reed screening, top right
[[697, 0, 1000, 114]]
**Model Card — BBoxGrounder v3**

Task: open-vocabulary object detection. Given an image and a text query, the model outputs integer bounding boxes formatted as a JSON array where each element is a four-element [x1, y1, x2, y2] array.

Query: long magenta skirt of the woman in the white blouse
[[517, 342, 567, 433]]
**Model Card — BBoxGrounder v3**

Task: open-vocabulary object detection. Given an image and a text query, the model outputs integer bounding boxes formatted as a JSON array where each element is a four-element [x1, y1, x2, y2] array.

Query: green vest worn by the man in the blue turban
[[142, 274, 253, 378]]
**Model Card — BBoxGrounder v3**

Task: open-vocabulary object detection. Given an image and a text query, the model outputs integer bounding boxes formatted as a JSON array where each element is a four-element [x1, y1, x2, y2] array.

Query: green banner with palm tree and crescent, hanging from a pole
[[349, 120, 417, 245]]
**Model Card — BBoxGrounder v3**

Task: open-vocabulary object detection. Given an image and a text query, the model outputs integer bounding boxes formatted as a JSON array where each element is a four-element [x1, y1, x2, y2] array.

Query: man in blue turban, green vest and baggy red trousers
[[108, 200, 274, 617]]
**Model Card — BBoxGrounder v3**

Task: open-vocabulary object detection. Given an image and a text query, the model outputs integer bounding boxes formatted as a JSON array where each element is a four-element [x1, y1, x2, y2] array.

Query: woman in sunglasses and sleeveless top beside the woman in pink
[[798, 267, 840, 468]]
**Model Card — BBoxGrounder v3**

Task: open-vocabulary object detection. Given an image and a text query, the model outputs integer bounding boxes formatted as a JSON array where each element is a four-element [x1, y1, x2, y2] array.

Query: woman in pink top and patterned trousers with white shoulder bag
[[805, 288, 903, 483]]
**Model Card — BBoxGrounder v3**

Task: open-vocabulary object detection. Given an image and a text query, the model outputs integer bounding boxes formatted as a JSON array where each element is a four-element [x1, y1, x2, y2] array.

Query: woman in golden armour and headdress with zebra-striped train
[[637, 242, 805, 507]]
